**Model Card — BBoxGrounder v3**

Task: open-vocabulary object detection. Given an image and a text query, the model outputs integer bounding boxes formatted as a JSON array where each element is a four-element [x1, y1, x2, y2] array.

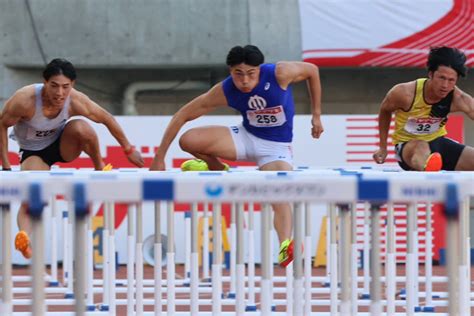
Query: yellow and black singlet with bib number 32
[[392, 78, 454, 144]]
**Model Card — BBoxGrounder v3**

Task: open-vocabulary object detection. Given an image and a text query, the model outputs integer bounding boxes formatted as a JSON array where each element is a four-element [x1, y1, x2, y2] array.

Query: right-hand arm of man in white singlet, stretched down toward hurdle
[[70, 91, 144, 168]]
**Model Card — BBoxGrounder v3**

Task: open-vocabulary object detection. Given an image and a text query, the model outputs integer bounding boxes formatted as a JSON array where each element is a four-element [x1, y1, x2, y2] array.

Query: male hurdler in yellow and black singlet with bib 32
[[373, 46, 474, 171]]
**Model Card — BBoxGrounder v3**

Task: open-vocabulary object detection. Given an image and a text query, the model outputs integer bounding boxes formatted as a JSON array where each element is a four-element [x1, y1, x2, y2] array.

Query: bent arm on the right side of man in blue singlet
[[275, 61, 324, 138]]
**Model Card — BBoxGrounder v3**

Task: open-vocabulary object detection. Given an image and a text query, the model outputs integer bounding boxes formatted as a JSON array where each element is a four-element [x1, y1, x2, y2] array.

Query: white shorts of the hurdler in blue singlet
[[229, 125, 293, 168]]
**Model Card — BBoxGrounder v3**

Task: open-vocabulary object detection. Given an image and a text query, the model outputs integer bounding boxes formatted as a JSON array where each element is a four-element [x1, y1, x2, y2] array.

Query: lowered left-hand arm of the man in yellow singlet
[[372, 85, 404, 164]]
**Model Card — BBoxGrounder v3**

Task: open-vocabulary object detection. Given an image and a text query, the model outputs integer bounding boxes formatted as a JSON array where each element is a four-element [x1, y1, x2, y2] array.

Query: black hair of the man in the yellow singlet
[[426, 46, 467, 77]]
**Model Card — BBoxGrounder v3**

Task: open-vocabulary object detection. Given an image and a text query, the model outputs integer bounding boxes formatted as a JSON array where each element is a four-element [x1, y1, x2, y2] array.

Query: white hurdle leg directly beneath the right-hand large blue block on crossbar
[[370, 204, 382, 315]]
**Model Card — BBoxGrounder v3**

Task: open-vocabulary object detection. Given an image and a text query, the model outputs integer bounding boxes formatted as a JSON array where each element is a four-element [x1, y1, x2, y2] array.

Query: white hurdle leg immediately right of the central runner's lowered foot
[[293, 202, 304, 315]]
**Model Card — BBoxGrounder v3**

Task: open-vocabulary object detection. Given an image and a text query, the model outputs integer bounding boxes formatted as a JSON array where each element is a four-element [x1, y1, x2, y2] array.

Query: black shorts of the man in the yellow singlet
[[395, 137, 466, 171]]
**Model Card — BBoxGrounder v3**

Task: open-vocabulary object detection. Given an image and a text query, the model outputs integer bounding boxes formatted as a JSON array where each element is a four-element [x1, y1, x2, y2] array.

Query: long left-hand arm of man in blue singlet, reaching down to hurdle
[[150, 83, 227, 170]]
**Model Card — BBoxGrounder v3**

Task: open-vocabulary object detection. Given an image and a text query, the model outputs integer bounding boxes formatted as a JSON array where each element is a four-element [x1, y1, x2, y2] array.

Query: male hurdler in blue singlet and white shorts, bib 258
[[150, 45, 323, 266]]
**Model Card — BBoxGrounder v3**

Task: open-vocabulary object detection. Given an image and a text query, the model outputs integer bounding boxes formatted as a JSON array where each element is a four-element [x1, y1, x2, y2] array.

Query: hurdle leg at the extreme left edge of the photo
[[0, 204, 13, 315]]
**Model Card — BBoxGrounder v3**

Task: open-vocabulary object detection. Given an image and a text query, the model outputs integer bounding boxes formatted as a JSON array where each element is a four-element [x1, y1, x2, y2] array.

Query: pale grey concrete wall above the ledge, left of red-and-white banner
[[0, 0, 301, 68]]
